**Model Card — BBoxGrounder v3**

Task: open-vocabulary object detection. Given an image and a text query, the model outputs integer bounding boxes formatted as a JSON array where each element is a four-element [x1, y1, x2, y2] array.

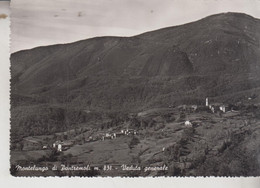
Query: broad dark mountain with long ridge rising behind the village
[[11, 13, 260, 135]]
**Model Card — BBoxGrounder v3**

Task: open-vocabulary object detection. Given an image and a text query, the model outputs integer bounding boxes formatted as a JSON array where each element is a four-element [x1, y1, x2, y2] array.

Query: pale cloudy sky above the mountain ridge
[[11, 0, 260, 52]]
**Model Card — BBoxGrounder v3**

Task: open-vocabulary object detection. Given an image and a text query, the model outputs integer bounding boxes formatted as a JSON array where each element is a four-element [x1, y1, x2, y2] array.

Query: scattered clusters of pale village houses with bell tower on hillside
[[17, 98, 237, 152]]
